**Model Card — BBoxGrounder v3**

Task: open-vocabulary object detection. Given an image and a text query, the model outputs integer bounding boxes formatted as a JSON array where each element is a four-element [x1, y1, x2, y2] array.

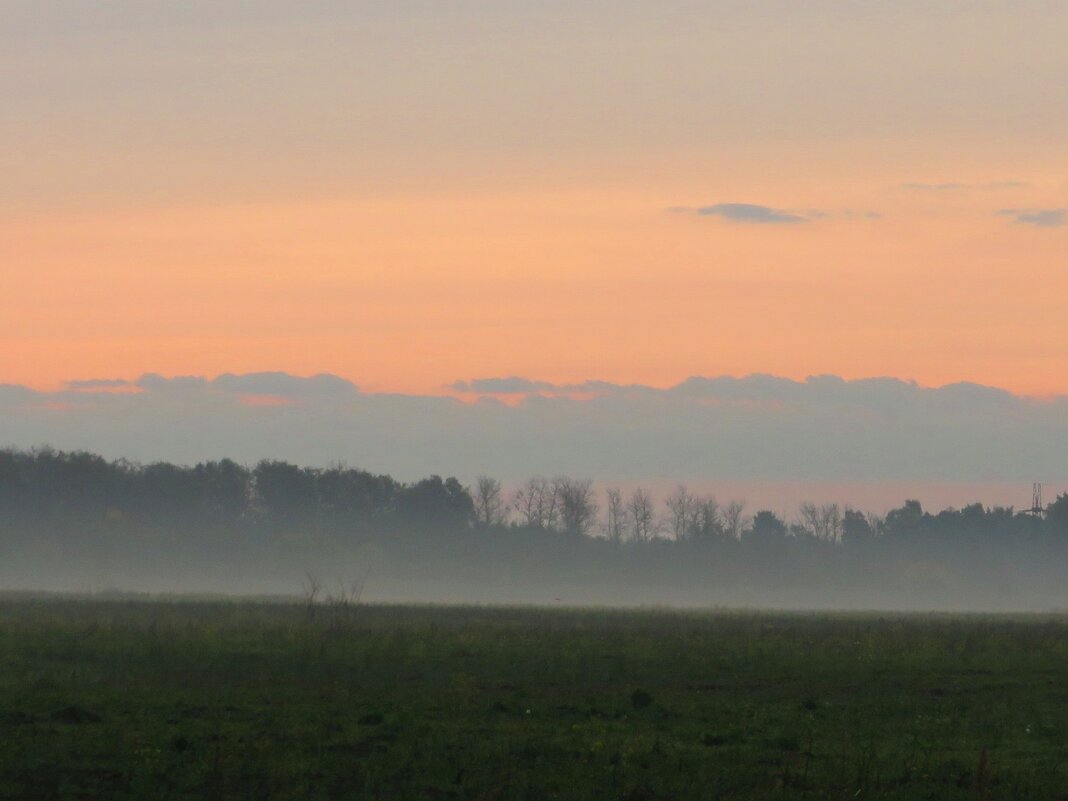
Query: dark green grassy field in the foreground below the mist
[[0, 600, 1068, 801]]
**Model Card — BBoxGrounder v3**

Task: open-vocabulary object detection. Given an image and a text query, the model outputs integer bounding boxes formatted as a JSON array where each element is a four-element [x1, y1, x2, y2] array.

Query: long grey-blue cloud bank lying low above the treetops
[[0, 373, 1068, 487]]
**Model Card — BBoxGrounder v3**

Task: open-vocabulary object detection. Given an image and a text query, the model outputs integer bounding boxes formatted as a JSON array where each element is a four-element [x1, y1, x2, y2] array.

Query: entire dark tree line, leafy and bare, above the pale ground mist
[[0, 447, 1068, 547]]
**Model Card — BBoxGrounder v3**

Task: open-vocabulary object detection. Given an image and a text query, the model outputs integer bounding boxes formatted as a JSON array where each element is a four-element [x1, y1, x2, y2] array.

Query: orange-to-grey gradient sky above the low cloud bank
[[0, 0, 1068, 395]]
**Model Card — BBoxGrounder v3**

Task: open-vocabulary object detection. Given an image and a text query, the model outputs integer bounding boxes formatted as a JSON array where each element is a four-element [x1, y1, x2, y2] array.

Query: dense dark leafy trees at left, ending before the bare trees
[[0, 449, 474, 542]]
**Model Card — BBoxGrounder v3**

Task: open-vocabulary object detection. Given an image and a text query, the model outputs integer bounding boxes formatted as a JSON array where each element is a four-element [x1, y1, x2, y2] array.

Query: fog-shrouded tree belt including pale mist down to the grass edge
[[0, 449, 1068, 611]]
